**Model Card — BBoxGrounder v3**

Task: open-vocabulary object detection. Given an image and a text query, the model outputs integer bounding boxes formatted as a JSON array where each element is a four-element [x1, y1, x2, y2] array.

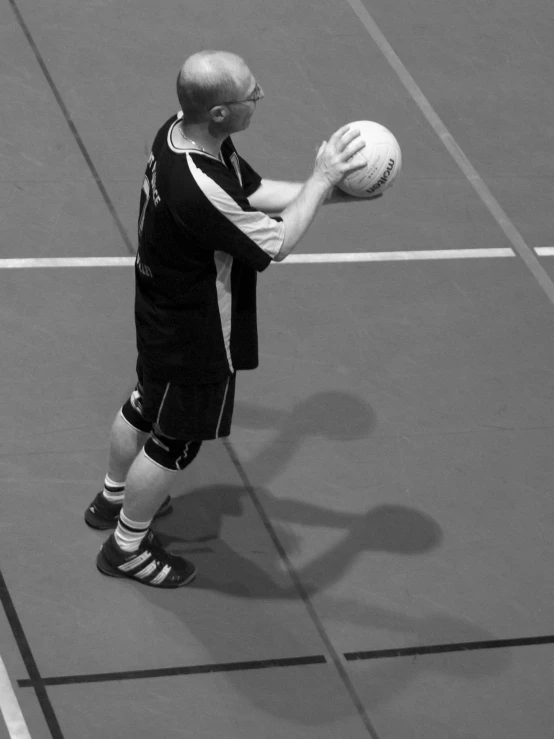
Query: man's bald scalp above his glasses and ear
[[177, 51, 250, 123]]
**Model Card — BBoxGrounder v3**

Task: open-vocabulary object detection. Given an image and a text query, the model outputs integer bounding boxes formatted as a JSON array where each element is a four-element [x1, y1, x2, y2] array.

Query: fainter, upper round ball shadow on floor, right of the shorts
[[286, 391, 376, 441]]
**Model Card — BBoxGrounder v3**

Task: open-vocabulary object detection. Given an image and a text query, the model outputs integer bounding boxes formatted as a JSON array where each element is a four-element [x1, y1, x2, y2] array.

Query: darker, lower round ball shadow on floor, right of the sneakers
[[358, 505, 443, 554]]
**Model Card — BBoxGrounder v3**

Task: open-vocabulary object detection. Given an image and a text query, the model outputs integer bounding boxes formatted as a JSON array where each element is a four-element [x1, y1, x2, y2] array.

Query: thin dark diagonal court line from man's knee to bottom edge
[[223, 439, 379, 739]]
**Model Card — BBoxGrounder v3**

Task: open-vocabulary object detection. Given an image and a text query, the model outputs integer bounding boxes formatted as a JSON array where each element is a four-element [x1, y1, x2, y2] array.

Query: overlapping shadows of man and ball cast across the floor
[[141, 392, 509, 725]]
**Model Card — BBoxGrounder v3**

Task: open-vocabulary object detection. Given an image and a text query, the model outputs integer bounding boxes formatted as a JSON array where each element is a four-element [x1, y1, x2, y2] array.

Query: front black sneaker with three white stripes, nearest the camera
[[96, 530, 196, 588]]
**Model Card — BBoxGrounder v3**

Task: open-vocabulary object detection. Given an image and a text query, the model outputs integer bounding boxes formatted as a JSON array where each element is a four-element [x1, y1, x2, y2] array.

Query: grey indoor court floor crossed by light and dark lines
[[0, 0, 554, 739]]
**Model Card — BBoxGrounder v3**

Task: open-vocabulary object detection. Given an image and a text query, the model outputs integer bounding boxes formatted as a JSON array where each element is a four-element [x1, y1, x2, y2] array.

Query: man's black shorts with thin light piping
[[132, 362, 236, 441]]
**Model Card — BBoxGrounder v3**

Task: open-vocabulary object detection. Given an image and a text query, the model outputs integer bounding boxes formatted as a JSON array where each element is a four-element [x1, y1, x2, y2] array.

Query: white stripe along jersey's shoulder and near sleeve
[[186, 152, 285, 257]]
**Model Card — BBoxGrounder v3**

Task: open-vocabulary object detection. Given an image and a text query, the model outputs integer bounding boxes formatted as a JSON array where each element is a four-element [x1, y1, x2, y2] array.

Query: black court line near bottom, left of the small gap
[[17, 655, 327, 688]]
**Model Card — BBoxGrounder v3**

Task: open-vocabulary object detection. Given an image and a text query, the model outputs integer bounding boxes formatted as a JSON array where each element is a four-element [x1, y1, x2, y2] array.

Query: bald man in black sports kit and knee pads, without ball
[[85, 51, 370, 588]]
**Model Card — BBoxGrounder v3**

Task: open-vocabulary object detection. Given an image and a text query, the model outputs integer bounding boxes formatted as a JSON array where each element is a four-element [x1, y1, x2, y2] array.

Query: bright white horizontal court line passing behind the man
[[0, 247, 515, 269]]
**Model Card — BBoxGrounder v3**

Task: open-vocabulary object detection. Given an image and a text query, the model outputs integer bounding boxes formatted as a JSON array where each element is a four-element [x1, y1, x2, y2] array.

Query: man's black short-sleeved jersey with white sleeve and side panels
[[135, 116, 284, 384]]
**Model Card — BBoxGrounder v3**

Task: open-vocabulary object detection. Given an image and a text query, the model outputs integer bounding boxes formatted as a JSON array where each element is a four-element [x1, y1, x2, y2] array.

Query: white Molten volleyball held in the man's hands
[[338, 121, 402, 198]]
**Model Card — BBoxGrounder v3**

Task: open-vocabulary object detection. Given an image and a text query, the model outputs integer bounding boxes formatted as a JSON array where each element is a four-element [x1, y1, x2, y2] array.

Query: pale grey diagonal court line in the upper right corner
[[347, 0, 554, 303]]
